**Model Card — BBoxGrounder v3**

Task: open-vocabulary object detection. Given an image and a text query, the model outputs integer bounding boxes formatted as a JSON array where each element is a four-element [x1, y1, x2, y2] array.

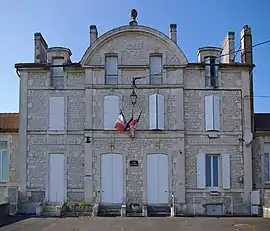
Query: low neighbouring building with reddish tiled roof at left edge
[[0, 113, 20, 211]]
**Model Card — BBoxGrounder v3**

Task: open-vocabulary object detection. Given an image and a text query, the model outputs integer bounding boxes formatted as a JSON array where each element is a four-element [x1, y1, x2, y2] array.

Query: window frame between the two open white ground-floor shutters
[[205, 154, 222, 191]]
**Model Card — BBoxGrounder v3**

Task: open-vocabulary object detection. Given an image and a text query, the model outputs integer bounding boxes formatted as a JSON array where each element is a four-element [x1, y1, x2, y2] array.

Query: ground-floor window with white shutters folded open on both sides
[[197, 154, 231, 190]]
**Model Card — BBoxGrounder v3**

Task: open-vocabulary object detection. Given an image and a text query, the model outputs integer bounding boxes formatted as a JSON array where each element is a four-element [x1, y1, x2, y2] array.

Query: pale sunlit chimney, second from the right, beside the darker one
[[221, 31, 235, 63]]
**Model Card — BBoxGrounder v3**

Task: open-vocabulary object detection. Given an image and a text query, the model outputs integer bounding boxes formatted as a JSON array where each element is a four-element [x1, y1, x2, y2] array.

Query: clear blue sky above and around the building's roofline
[[0, 0, 270, 112]]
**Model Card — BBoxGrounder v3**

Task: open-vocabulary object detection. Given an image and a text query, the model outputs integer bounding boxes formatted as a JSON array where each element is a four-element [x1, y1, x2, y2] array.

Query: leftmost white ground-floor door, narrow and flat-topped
[[49, 154, 65, 202]]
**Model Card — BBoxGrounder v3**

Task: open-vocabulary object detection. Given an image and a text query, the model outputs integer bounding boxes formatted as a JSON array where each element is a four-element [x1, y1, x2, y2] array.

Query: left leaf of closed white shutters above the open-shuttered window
[[204, 95, 214, 131]]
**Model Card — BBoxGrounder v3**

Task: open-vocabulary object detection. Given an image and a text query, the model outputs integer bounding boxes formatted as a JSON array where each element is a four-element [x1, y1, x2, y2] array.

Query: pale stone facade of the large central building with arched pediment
[[15, 11, 253, 214]]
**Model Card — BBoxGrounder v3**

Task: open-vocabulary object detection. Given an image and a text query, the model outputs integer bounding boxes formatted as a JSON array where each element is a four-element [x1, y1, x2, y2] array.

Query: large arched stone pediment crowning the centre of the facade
[[81, 26, 188, 66]]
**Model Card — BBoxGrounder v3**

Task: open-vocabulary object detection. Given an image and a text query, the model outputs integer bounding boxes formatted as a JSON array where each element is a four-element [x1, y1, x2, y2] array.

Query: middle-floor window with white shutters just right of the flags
[[149, 94, 165, 130]]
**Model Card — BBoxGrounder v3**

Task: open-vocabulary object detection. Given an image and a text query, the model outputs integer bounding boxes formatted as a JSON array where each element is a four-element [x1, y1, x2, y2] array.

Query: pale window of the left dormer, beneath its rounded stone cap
[[51, 58, 64, 87]]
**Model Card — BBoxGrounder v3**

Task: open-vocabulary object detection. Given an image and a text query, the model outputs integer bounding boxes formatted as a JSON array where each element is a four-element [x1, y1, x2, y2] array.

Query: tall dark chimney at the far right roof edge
[[241, 25, 253, 64]]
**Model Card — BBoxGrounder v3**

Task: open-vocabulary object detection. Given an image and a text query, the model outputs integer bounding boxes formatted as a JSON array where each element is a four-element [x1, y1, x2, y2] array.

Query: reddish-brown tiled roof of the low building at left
[[0, 113, 19, 132]]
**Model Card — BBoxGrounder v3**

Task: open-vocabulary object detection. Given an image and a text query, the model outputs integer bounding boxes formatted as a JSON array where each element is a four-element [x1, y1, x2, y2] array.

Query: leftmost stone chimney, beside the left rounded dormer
[[34, 33, 48, 63]]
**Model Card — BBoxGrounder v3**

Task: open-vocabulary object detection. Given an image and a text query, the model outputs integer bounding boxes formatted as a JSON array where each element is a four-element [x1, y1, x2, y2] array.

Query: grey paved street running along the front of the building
[[0, 217, 270, 231]]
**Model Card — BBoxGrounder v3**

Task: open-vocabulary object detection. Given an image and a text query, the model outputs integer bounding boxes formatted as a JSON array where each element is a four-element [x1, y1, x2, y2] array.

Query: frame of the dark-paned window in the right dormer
[[204, 56, 219, 88]]
